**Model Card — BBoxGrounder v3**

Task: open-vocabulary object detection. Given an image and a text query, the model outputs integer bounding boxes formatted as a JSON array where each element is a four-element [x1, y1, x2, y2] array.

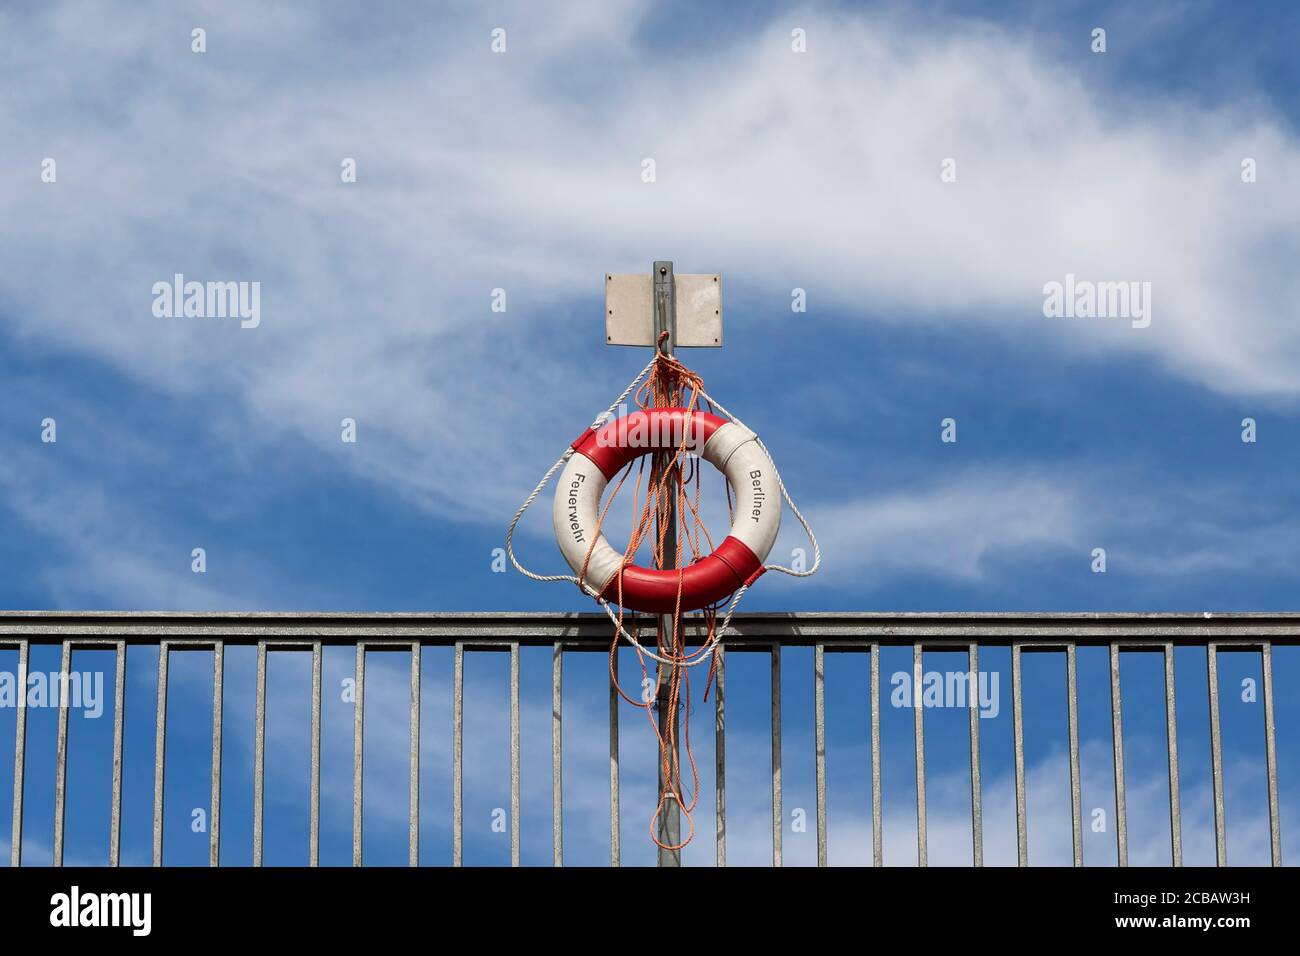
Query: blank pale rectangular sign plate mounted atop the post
[[605, 272, 723, 349]]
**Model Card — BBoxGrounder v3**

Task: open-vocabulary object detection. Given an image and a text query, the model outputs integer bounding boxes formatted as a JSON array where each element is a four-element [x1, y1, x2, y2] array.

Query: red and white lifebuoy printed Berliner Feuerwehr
[[551, 408, 781, 614]]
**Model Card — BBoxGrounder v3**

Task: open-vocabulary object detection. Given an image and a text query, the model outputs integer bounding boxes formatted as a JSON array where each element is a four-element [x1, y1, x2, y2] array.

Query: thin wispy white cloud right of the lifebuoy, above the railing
[[754, 459, 1300, 594]]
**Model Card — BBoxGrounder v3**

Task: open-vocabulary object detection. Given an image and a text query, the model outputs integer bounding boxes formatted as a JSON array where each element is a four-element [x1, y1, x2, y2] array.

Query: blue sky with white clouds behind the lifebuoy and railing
[[0, 0, 1300, 862]]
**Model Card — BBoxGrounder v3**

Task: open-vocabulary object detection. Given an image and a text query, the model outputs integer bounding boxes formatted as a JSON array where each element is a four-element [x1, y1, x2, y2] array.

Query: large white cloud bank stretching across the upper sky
[[0, 4, 1300, 530]]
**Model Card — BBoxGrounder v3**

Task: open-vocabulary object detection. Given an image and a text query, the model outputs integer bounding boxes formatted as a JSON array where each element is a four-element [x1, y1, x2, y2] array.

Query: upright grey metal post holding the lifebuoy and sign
[[653, 261, 685, 866]]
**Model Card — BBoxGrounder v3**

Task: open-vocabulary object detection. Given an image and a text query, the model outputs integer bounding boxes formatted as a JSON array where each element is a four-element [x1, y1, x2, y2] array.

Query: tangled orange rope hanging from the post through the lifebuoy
[[579, 343, 732, 851]]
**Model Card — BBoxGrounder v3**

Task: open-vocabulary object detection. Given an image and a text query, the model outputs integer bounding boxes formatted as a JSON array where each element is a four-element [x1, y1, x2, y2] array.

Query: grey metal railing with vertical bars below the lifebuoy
[[0, 611, 1284, 866]]
